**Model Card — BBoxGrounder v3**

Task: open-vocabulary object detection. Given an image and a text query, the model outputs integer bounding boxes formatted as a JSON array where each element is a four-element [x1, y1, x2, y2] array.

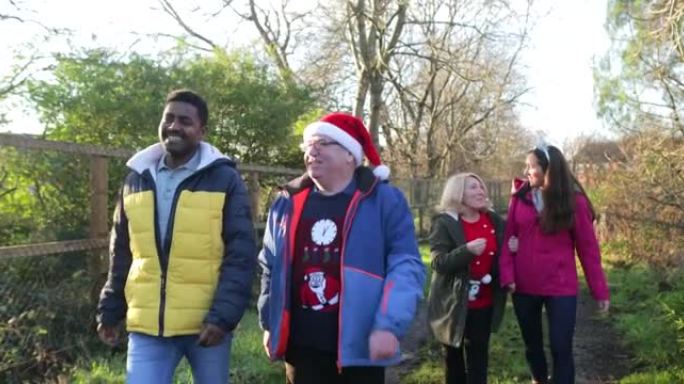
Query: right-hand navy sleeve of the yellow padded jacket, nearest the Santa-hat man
[[204, 168, 256, 332]]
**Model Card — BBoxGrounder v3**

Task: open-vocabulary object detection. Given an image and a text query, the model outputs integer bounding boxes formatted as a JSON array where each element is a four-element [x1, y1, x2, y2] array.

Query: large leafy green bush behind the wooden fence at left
[[0, 50, 317, 244]]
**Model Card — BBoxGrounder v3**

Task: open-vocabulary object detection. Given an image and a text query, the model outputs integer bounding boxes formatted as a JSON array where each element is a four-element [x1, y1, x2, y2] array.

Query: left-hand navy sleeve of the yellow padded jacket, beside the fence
[[96, 192, 132, 327]]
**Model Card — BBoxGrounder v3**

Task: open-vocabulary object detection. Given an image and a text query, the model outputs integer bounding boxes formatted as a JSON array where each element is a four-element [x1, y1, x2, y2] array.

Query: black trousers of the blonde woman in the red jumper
[[444, 307, 493, 384]]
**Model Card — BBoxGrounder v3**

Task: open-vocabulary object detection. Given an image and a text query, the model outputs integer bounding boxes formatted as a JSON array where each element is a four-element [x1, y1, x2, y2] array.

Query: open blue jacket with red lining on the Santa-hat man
[[258, 167, 425, 368]]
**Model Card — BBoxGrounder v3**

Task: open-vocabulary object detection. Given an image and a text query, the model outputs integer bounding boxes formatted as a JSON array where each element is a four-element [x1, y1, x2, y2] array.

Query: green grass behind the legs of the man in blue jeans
[[70, 311, 285, 384]]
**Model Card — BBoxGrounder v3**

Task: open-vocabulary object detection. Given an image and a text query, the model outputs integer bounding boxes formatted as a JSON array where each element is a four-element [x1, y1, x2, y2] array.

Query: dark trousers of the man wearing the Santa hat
[[285, 348, 385, 384]]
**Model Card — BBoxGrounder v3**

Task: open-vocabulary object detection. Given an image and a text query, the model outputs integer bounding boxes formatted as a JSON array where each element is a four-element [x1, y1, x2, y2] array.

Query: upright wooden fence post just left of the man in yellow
[[88, 156, 109, 302]]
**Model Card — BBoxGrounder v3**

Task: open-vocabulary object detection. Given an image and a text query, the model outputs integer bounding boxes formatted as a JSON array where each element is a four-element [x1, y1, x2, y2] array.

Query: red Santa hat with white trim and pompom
[[304, 112, 390, 180]]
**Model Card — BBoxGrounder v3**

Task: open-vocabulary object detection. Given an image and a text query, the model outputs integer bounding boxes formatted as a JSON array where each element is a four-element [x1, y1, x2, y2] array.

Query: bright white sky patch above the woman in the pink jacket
[[519, 0, 610, 146]]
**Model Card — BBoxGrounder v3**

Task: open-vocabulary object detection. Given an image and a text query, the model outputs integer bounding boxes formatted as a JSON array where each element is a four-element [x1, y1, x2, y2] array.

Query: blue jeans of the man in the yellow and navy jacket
[[126, 332, 232, 384]]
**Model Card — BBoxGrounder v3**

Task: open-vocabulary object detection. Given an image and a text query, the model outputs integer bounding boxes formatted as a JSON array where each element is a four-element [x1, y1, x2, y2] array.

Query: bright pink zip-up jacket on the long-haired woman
[[499, 179, 610, 300]]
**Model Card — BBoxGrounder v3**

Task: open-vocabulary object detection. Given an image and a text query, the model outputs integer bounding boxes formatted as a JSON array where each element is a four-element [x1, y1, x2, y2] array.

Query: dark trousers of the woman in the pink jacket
[[513, 293, 577, 384]]
